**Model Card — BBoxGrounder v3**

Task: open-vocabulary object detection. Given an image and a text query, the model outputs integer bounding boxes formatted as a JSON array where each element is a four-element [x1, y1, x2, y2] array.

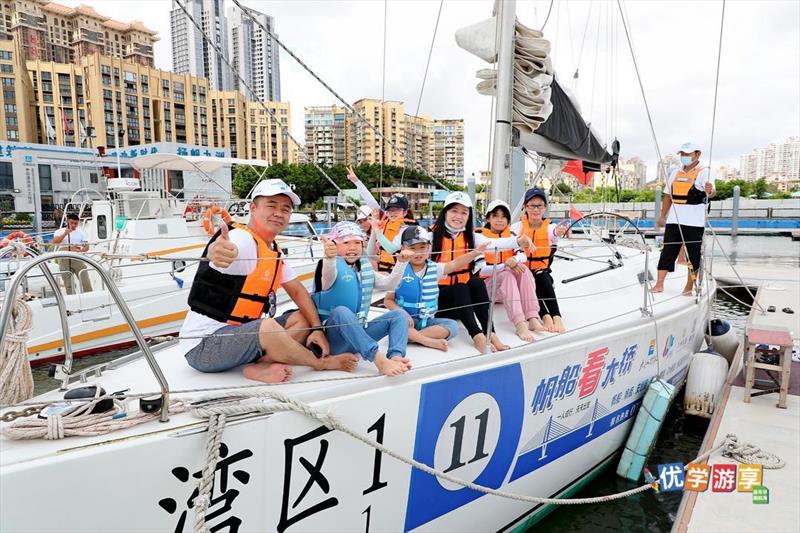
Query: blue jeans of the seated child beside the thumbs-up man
[[325, 306, 408, 361]]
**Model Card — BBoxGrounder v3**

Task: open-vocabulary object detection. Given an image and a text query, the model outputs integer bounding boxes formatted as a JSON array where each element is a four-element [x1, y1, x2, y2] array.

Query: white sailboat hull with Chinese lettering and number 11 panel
[[0, 272, 707, 531]]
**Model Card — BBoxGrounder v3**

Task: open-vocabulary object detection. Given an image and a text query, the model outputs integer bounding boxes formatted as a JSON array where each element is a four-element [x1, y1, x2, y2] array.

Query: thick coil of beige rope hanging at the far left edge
[[0, 298, 33, 404]]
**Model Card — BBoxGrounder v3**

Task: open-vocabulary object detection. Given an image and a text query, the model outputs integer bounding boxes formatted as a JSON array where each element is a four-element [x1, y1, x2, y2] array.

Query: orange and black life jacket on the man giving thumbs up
[[189, 223, 282, 326]]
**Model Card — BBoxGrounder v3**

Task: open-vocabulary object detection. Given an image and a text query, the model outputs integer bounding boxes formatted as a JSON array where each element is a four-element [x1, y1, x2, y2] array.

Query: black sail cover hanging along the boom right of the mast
[[520, 79, 611, 168]]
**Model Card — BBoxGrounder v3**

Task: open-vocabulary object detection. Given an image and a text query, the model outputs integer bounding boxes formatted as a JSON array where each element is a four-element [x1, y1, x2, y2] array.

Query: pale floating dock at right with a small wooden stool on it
[[672, 278, 800, 533]]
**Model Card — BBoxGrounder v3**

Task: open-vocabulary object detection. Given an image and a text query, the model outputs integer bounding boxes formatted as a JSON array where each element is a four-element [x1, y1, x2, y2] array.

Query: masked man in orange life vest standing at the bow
[[650, 142, 716, 295]]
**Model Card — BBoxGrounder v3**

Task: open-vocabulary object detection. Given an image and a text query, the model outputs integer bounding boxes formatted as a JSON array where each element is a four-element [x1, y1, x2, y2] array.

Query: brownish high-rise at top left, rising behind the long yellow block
[[0, 0, 158, 66]]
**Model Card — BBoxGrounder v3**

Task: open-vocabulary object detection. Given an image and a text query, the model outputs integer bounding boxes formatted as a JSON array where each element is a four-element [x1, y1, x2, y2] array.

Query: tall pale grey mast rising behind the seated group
[[492, 0, 517, 202]]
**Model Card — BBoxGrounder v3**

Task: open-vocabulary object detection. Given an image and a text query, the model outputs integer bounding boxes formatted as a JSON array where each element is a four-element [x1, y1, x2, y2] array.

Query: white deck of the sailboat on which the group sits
[[0, 244, 696, 467]]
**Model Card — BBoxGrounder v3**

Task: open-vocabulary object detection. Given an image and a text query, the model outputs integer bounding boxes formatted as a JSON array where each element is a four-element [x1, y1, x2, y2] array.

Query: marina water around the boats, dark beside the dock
[[28, 235, 800, 533]]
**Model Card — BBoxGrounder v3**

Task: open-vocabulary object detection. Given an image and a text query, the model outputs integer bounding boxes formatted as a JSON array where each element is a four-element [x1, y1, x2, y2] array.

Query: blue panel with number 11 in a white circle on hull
[[404, 364, 525, 531]]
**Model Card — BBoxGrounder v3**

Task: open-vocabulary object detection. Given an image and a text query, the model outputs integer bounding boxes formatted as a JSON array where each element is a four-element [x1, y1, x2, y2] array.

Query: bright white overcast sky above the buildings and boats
[[60, 0, 800, 178]]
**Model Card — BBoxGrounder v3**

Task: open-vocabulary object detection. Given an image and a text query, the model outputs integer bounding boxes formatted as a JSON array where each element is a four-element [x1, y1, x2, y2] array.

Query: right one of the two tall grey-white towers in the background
[[228, 6, 281, 102]]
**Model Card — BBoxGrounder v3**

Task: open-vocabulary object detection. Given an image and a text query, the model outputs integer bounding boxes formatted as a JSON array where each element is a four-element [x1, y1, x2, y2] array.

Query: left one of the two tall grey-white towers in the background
[[170, 0, 233, 91]]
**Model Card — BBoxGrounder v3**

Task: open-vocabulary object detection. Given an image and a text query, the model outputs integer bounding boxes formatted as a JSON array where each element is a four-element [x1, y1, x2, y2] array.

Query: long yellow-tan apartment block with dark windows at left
[[0, 46, 295, 163]]
